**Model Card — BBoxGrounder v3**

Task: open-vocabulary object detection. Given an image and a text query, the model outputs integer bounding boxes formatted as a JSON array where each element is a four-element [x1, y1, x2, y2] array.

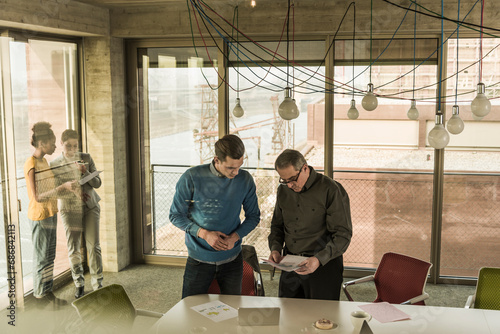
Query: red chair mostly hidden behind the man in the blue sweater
[[208, 245, 265, 296]]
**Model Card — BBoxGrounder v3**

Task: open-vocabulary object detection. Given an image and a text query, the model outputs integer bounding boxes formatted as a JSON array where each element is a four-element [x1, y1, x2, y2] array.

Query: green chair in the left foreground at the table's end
[[72, 284, 163, 333]]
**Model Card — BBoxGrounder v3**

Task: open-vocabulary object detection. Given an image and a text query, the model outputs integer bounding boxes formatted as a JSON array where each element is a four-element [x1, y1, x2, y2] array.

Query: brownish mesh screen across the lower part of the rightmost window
[[441, 175, 500, 277]]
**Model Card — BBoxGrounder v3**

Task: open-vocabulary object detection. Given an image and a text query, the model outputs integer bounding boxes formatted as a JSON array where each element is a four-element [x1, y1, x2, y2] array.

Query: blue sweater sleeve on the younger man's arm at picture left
[[169, 172, 200, 237]]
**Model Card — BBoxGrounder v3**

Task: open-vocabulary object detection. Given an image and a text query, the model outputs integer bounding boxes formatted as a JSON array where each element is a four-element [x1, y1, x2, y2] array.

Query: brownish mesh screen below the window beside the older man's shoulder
[[335, 173, 432, 268]]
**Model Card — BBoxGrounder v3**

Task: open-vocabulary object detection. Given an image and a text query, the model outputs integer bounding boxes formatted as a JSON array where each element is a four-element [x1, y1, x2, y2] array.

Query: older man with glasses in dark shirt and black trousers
[[268, 149, 352, 300]]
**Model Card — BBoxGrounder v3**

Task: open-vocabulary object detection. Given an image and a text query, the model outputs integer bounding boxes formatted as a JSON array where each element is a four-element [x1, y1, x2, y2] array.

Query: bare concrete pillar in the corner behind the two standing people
[[83, 36, 132, 271]]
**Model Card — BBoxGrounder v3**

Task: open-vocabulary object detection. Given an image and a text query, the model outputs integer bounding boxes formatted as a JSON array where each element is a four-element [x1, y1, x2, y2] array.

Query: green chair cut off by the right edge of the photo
[[465, 267, 500, 310]]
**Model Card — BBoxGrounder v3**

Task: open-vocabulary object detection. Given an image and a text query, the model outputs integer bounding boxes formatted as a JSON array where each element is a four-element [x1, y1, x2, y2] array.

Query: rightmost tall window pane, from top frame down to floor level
[[441, 38, 500, 277]]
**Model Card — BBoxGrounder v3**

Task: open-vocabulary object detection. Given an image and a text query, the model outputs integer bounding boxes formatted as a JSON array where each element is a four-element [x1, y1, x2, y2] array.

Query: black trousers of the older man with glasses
[[279, 256, 344, 300]]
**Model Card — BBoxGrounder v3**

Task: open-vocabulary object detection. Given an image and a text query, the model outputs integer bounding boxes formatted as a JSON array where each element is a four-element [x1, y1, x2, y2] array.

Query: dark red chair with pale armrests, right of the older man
[[342, 253, 432, 305]]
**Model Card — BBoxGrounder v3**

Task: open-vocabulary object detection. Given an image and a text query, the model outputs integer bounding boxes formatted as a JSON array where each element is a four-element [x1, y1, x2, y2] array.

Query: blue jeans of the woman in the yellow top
[[30, 215, 57, 298]]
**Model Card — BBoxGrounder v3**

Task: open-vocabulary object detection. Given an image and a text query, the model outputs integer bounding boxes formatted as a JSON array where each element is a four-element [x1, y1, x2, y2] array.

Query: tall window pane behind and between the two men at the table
[[229, 41, 325, 256]]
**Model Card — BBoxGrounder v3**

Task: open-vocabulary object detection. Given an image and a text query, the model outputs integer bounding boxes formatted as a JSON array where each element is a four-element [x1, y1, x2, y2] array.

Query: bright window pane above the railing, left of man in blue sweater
[[139, 48, 219, 165]]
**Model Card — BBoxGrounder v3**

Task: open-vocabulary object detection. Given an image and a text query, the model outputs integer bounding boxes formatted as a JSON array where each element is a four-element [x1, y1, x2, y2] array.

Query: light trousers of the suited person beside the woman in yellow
[[61, 204, 103, 290]]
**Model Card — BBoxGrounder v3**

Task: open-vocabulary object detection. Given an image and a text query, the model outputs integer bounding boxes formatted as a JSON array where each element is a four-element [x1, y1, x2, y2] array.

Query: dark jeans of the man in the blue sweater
[[182, 252, 243, 298]]
